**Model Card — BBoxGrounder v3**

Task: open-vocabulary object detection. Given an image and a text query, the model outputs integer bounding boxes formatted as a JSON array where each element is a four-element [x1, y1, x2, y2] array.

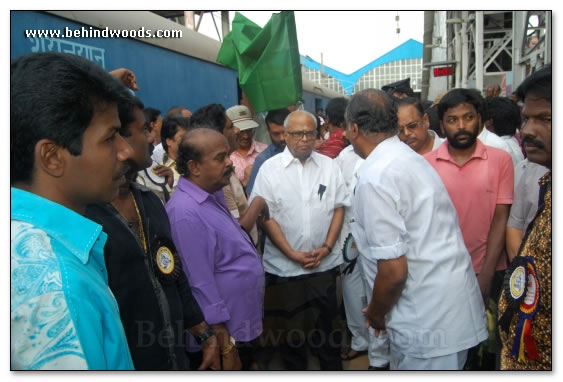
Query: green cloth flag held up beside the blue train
[[217, 11, 303, 112]]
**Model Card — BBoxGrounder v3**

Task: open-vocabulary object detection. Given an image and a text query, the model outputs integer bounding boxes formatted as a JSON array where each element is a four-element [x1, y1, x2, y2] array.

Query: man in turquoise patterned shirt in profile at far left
[[10, 53, 133, 370]]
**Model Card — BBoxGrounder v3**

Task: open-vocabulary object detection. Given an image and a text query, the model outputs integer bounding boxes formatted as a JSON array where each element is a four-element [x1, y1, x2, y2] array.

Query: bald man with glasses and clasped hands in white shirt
[[250, 111, 350, 370]]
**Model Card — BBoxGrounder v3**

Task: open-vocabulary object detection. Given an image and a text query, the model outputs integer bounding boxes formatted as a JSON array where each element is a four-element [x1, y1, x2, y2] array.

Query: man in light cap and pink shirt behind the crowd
[[227, 105, 268, 187]]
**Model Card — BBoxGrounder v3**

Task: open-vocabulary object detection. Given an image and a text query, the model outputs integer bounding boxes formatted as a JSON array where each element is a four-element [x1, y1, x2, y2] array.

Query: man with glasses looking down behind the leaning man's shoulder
[[395, 97, 444, 155]]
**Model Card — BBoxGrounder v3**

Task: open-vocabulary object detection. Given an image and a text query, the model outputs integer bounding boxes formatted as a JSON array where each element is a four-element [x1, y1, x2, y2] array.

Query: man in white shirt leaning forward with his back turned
[[346, 89, 488, 370]]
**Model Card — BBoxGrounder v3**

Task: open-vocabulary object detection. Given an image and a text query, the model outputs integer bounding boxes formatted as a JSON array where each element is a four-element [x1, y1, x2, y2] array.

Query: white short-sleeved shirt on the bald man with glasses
[[249, 147, 350, 277]]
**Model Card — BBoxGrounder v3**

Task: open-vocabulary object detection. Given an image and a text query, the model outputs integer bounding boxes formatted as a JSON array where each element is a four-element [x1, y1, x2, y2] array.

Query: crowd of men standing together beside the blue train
[[10, 53, 552, 370]]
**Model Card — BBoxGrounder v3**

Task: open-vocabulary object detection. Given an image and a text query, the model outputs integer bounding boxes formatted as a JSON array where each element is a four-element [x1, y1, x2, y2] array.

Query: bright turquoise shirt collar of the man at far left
[[11, 187, 107, 264]]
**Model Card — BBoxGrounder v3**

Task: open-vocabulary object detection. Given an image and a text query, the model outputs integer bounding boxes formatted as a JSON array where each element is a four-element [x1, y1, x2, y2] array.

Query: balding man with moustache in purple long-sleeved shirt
[[166, 128, 264, 370]]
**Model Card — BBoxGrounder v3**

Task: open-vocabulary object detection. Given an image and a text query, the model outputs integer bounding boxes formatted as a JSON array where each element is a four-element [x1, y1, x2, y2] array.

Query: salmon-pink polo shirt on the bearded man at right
[[424, 140, 514, 274]]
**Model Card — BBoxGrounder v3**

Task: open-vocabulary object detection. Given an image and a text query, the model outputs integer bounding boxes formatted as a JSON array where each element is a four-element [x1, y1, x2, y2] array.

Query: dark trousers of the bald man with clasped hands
[[261, 269, 342, 370]]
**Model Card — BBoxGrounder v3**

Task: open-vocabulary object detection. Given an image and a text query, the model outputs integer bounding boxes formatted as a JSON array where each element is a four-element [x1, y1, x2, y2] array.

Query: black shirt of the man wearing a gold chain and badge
[[86, 183, 204, 370]]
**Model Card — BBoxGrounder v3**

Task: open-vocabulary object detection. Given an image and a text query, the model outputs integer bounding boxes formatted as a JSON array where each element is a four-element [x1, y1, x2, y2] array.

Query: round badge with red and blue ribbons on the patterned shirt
[[499, 256, 540, 361]]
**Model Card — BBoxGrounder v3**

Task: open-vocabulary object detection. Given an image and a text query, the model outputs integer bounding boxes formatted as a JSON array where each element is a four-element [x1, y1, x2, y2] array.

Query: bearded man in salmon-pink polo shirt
[[424, 89, 514, 306]]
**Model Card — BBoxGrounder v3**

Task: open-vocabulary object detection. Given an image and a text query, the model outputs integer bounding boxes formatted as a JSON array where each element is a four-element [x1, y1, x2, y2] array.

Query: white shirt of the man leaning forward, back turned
[[352, 136, 488, 358]]
